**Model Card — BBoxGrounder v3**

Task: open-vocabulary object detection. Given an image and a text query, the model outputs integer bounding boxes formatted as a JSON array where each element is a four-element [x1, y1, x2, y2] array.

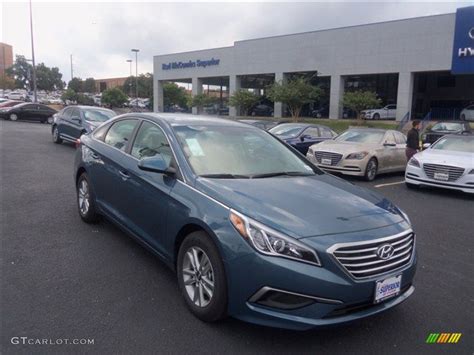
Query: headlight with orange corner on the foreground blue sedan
[[229, 210, 321, 266]]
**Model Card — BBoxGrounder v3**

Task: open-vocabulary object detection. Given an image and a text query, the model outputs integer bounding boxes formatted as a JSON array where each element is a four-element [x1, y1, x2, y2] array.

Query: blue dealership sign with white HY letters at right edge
[[451, 6, 474, 74]]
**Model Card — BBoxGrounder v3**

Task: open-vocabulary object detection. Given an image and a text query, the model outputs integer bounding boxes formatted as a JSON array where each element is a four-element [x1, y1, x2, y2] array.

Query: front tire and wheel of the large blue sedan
[[177, 231, 227, 322]]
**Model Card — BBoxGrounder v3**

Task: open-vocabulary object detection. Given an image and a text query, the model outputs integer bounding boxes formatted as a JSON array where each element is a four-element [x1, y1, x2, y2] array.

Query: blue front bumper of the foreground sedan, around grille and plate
[[226, 223, 416, 330]]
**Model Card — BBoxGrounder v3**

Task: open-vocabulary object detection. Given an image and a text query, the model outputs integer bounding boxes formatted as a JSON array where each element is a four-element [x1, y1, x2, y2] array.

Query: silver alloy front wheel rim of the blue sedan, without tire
[[182, 246, 214, 307]]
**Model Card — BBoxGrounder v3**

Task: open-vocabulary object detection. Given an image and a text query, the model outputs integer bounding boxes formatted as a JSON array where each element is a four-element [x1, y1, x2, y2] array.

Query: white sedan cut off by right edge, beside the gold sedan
[[405, 135, 474, 193]]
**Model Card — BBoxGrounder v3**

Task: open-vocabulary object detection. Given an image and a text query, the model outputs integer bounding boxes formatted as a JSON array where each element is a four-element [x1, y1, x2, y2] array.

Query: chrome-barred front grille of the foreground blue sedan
[[329, 232, 415, 279]]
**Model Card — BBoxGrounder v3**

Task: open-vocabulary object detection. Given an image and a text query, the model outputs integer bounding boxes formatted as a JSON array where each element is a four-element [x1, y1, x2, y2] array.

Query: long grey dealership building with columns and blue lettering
[[154, 6, 474, 120]]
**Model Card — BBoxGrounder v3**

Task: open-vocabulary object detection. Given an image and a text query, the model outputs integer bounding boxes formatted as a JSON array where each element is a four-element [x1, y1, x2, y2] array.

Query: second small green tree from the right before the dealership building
[[267, 77, 323, 122]]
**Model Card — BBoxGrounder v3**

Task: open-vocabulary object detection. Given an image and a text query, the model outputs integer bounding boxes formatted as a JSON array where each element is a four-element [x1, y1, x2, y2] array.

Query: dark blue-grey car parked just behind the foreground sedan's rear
[[51, 106, 117, 144]]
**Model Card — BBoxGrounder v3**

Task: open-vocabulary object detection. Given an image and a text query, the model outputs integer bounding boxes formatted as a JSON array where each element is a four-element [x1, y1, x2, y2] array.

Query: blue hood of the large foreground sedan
[[196, 174, 404, 239]]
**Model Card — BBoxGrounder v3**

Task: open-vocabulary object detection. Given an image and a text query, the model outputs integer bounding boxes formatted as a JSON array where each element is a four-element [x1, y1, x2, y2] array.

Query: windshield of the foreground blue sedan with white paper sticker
[[174, 125, 320, 179]]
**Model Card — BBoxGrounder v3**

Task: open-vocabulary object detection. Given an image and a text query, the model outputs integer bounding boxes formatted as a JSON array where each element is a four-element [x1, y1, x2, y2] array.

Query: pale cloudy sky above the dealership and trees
[[0, 0, 473, 82]]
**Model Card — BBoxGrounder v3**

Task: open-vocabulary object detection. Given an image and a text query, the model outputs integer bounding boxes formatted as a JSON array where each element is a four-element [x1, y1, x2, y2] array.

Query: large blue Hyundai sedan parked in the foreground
[[74, 113, 416, 329]]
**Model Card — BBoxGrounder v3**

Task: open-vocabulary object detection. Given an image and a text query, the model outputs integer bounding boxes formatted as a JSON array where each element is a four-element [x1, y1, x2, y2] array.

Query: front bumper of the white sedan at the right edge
[[405, 164, 474, 194]]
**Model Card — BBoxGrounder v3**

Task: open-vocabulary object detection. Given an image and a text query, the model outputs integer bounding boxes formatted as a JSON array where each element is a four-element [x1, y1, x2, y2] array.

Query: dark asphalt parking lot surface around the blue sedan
[[0, 121, 474, 354]]
